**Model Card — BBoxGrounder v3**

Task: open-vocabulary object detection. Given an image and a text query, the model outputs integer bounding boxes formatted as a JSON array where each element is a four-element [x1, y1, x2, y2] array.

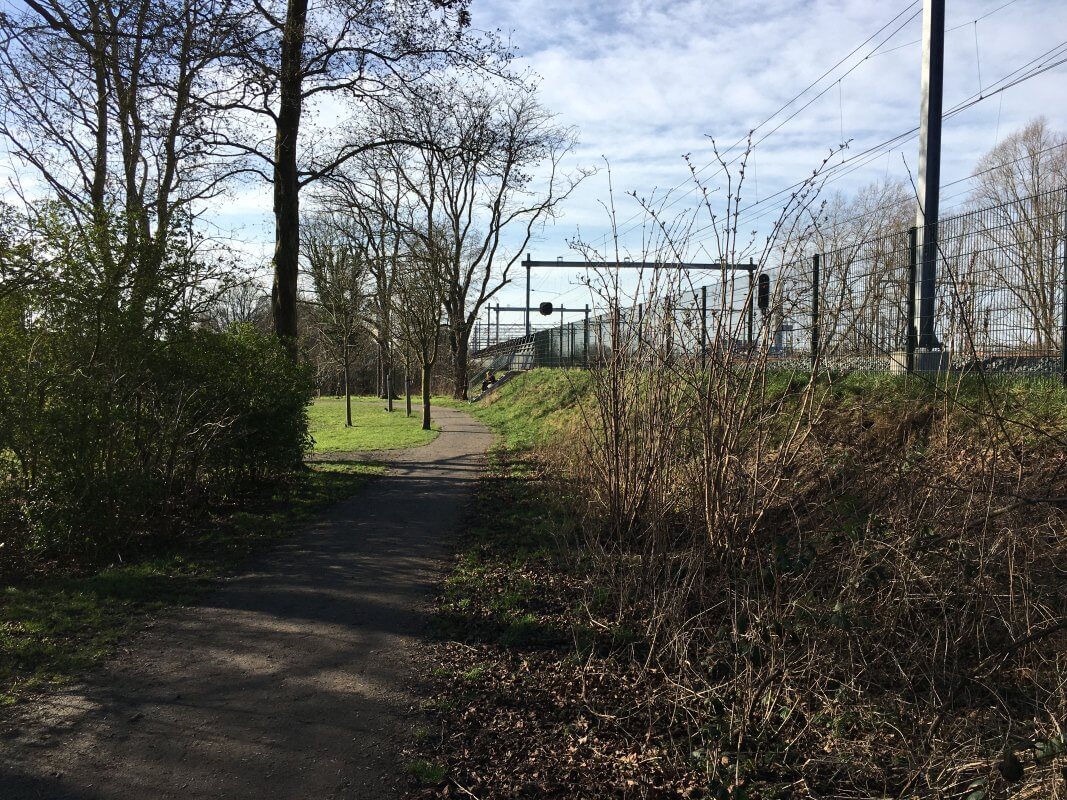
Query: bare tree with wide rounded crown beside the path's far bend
[[386, 82, 589, 398]]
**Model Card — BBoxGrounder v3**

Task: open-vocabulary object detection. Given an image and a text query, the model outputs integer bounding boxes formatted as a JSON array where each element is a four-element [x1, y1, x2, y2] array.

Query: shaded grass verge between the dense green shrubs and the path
[[0, 462, 383, 705]]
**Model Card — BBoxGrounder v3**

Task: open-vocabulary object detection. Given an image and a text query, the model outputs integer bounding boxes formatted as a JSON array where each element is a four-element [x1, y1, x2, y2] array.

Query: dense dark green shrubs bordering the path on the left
[[0, 297, 310, 572]]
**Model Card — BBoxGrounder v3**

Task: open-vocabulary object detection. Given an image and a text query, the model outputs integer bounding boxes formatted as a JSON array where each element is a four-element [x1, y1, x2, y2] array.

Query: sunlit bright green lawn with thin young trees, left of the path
[[307, 397, 441, 453]]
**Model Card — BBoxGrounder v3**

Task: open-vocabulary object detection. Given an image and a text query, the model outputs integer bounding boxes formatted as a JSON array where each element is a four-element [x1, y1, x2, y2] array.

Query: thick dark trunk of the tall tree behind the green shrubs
[[271, 0, 307, 361]]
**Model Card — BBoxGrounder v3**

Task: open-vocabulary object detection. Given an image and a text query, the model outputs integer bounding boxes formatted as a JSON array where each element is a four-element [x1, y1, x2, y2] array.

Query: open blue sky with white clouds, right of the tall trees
[[458, 0, 1067, 317]]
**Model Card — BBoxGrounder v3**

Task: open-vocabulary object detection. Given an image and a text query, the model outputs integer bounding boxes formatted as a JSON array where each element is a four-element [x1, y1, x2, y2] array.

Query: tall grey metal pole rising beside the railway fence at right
[[915, 0, 944, 350]]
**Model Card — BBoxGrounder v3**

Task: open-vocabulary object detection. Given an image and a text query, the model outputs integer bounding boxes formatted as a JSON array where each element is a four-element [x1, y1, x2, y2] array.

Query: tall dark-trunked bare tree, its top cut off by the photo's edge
[[223, 0, 508, 355]]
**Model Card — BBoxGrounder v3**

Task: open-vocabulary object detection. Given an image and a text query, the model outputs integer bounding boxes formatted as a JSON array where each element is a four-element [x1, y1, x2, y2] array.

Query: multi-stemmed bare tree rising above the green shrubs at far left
[[0, 0, 248, 333]]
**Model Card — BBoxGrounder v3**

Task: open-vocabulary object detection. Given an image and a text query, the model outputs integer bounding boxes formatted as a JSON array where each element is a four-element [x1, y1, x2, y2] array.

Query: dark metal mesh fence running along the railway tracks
[[475, 189, 1067, 380]]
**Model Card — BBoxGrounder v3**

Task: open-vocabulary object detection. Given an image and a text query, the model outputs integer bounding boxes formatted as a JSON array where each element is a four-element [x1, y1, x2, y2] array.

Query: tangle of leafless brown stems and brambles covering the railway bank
[[566, 147, 1067, 800]]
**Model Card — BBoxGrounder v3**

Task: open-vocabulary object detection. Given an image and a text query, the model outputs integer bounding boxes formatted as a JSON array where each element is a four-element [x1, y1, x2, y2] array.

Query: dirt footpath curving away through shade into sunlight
[[0, 409, 491, 800]]
